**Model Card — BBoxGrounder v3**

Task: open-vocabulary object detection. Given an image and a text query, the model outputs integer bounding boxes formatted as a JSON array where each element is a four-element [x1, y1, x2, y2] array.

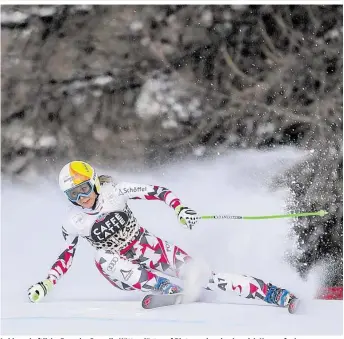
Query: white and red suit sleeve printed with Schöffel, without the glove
[[116, 182, 181, 209]]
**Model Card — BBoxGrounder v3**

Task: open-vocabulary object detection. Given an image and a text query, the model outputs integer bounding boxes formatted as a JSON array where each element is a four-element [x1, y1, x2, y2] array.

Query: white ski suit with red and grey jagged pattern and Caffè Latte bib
[[48, 180, 268, 299]]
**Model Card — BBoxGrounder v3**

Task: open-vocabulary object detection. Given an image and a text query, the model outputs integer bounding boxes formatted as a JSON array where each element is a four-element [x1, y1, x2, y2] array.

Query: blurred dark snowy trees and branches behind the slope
[[1, 5, 343, 298]]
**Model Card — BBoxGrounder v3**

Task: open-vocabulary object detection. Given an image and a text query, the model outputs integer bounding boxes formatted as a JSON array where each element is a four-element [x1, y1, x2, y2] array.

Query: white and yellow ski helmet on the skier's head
[[59, 161, 100, 203]]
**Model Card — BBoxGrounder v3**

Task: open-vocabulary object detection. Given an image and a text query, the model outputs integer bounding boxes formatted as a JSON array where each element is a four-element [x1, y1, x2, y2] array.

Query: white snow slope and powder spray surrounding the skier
[[1, 148, 343, 336]]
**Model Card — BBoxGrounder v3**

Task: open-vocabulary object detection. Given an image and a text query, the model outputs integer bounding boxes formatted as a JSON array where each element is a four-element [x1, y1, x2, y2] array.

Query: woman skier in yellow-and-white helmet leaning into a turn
[[28, 161, 296, 308]]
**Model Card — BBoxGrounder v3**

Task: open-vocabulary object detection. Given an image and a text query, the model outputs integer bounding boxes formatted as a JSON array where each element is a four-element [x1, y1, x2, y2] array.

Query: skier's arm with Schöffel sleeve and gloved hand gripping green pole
[[115, 182, 198, 229]]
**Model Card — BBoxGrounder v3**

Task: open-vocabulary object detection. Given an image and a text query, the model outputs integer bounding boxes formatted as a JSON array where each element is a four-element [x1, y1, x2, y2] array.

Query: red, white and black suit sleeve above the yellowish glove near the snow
[[48, 226, 78, 285]]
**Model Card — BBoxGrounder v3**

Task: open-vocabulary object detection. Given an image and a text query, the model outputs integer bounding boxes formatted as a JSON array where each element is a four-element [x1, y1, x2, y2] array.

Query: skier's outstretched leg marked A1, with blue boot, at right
[[206, 273, 295, 306]]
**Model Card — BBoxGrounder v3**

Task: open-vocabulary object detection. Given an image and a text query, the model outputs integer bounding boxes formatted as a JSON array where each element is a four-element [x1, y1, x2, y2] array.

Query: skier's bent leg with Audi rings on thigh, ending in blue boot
[[96, 250, 180, 294]]
